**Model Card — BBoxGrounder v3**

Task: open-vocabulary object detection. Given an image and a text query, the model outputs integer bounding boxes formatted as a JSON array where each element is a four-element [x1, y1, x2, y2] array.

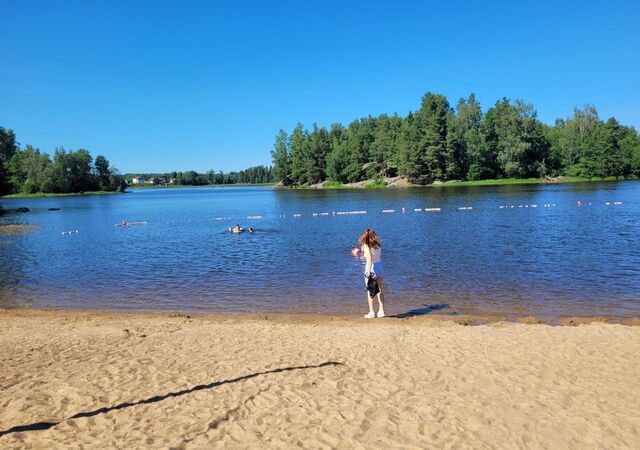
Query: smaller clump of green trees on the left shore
[[0, 127, 127, 195]]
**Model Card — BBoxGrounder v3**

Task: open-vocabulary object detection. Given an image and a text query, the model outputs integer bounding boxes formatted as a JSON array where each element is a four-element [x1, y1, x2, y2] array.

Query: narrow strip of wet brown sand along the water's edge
[[5, 306, 640, 327]]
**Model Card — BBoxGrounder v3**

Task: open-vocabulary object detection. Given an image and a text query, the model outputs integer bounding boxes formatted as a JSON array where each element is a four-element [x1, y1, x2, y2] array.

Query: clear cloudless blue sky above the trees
[[0, 0, 640, 172]]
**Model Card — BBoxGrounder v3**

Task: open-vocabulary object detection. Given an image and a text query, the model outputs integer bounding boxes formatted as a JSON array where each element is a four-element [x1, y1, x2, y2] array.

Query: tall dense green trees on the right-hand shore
[[271, 92, 640, 186]]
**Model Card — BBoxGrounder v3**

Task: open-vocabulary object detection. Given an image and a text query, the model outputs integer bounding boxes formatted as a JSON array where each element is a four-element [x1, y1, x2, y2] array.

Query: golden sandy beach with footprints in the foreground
[[0, 310, 640, 449]]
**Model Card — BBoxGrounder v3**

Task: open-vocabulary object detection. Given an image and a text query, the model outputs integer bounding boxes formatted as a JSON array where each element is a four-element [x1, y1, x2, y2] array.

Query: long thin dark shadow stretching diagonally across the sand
[[0, 361, 344, 437]]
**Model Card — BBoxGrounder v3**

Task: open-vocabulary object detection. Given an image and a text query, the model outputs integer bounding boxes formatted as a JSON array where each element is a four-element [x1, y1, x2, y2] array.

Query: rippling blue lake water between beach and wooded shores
[[0, 181, 640, 318]]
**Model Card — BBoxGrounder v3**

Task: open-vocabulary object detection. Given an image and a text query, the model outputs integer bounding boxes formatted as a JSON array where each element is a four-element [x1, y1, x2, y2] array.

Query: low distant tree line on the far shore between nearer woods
[[125, 166, 273, 186]]
